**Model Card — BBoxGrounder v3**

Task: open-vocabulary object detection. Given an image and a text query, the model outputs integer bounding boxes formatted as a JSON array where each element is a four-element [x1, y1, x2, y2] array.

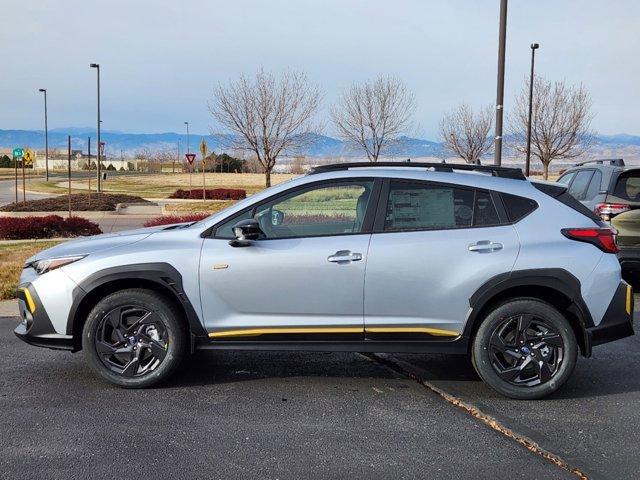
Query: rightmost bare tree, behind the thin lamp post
[[511, 76, 593, 180]]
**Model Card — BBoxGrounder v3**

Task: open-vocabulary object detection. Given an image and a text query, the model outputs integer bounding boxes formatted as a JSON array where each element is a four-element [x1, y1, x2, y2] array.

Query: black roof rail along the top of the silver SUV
[[308, 162, 527, 180]]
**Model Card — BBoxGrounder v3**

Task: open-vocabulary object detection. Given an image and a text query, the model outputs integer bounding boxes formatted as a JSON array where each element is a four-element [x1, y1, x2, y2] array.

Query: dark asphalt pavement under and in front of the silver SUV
[[0, 306, 640, 479]]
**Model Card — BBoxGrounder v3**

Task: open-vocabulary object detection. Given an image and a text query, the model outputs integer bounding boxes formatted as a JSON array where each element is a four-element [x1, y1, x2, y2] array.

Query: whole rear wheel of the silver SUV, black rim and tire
[[471, 298, 578, 400]]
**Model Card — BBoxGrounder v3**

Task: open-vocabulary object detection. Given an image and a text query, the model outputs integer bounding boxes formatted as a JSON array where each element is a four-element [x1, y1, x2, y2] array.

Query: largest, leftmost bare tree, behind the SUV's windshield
[[209, 70, 321, 187]]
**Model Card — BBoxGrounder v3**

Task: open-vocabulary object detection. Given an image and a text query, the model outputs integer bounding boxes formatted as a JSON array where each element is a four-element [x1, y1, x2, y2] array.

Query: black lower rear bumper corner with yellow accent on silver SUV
[[586, 281, 634, 347]]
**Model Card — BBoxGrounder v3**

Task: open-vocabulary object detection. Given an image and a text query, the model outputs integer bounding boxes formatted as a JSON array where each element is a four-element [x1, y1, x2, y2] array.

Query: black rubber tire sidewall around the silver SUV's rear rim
[[472, 299, 578, 400]]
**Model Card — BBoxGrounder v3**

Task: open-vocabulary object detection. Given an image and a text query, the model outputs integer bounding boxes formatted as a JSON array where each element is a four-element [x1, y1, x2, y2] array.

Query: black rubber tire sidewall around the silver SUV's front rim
[[82, 290, 186, 388]]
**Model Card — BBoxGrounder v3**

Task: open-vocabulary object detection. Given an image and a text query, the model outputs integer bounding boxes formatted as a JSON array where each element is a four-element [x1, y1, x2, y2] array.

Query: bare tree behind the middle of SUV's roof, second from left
[[331, 76, 416, 162]]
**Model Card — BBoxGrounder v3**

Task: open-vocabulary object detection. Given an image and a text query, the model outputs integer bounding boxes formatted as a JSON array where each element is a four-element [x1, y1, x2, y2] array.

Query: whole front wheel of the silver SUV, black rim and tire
[[82, 289, 187, 388]]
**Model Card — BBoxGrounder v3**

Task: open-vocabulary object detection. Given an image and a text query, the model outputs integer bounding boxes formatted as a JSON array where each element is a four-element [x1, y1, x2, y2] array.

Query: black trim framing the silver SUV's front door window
[[208, 176, 383, 241]]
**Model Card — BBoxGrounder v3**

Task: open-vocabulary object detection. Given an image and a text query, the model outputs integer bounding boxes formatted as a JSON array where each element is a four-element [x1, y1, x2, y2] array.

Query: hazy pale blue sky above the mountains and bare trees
[[0, 0, 640, 139]]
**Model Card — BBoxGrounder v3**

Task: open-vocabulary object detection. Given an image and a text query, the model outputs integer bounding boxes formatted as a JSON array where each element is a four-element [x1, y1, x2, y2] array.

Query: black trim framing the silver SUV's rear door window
[[373, 177, 510, 234]]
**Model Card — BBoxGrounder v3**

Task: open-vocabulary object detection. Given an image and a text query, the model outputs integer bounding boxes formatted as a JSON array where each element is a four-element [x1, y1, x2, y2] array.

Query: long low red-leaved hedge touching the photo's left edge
[[0, 215, 102, 240]]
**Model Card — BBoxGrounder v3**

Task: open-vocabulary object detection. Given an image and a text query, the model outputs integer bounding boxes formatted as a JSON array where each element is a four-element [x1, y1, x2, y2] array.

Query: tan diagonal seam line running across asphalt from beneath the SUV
[[360, 353, 590, 480]]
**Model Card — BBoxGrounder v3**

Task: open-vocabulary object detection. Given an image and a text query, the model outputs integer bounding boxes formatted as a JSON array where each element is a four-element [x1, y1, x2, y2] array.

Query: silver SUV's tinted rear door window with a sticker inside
[[384, 181, 499, 232]]
